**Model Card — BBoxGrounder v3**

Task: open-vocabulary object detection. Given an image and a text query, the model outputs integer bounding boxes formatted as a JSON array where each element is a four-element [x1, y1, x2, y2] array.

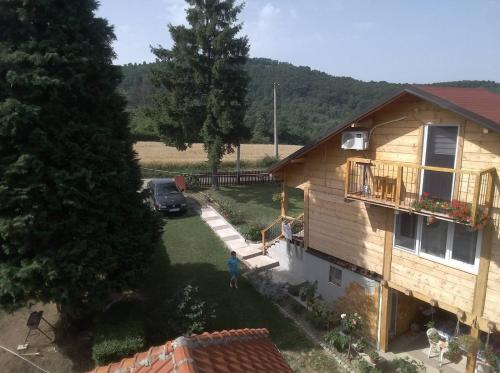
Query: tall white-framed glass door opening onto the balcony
[[421, 126, 458, 201]]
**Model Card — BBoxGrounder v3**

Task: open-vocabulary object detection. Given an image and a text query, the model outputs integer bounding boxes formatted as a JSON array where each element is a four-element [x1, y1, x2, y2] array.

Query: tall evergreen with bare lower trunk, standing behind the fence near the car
[[151, 0, 249, 187]]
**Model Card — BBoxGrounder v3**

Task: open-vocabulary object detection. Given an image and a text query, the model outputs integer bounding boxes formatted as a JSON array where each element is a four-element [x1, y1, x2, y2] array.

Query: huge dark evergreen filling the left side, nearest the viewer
[[0, 0, 159, 318]]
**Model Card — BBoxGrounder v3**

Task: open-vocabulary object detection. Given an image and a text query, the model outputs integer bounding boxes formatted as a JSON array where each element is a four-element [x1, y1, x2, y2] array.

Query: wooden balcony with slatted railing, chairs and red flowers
[[345, 158, 496, 228]]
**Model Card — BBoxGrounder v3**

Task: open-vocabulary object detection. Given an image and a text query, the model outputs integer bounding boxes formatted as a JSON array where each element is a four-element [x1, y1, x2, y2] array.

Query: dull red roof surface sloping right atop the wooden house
[[414, 85, 500, 126]]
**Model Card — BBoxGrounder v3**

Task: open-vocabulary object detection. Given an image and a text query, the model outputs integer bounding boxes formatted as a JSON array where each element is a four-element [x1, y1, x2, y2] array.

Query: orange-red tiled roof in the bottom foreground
[[89, 329, 292, 373]]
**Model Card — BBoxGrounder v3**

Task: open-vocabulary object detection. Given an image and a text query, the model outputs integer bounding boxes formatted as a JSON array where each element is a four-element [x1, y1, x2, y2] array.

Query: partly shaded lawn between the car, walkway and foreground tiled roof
[[154, 209, 338, 372]]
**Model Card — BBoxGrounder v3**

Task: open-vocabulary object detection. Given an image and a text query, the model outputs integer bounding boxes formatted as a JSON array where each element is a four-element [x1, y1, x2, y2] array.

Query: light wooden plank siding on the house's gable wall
[[285, 96, 500, 330]]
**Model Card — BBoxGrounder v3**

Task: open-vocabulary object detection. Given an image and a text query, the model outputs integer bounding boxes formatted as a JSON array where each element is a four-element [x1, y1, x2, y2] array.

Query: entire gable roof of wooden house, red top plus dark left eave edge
[[268, 85, 500, 173]]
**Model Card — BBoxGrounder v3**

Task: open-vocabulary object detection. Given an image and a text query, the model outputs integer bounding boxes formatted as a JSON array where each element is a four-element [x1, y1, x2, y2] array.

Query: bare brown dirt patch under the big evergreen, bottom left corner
[[0, 304, 93, 373]]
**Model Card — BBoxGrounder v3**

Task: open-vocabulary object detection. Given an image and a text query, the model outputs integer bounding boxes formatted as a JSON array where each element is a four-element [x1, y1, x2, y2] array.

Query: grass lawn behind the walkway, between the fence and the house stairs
[[211, 183, 304, 225]]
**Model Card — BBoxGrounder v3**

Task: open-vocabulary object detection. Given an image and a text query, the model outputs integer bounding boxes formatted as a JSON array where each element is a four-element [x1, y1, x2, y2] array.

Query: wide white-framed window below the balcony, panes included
[[394, 213, 481, 273]]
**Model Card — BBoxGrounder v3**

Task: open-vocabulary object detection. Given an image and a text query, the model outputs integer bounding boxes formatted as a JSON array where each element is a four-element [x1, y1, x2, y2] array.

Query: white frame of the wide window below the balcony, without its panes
[[392, 211, 483, 275]]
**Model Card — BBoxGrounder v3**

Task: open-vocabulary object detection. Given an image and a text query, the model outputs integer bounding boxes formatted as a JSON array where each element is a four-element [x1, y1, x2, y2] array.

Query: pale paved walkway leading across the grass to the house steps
[[200, 206, 279, 272]]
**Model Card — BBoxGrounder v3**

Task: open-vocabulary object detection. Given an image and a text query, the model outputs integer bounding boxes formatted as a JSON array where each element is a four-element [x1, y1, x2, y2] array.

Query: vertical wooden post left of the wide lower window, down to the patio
[[379, 210, 394, 352]]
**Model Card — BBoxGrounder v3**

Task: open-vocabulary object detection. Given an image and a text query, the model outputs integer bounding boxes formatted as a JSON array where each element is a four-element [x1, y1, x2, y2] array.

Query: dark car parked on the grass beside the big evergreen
[[147, 179, 187, 212]]
